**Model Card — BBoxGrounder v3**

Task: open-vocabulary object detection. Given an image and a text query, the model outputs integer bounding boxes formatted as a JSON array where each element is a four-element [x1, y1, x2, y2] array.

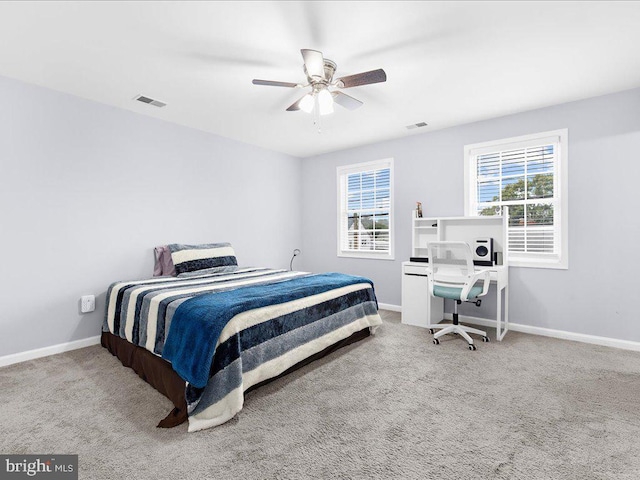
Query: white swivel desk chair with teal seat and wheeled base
[[427, 242, 490, 350]]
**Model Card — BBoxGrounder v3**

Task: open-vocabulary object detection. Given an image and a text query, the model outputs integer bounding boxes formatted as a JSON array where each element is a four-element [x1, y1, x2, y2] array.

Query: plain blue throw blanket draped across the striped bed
[[162, 273, 373, 388]]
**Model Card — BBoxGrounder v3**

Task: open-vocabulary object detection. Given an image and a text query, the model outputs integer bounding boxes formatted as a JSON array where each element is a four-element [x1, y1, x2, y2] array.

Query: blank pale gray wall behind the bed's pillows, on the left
[[0, 77, 301, 356]]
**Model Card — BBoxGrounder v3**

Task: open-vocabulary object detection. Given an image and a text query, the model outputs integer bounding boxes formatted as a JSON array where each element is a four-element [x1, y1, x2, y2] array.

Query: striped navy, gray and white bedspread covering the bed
[[103, 268, 382, 432]]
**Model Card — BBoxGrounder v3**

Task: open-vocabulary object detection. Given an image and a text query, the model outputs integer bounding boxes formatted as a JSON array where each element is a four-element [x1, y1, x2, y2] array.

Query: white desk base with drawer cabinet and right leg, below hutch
[[402, 262, 509, 341]]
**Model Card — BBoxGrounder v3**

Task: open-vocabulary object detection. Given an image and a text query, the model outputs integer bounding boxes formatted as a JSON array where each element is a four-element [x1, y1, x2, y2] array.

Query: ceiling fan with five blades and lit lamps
[[253, 49, 387, 115]]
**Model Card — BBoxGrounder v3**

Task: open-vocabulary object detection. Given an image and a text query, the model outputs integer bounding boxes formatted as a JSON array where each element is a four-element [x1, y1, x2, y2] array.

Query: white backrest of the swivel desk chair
[[427, 242, 474, 294]]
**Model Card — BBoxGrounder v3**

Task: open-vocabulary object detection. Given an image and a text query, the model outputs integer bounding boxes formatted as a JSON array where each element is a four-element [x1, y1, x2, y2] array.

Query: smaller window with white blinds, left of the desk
[[338, 159, 393, 260]]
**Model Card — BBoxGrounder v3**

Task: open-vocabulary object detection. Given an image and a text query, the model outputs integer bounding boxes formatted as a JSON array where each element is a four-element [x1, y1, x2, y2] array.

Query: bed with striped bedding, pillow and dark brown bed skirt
[[102, 243, 382, 432]]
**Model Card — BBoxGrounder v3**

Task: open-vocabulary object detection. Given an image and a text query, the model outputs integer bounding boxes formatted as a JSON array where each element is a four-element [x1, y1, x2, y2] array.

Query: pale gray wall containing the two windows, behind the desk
[[302, 89, 640, 341]]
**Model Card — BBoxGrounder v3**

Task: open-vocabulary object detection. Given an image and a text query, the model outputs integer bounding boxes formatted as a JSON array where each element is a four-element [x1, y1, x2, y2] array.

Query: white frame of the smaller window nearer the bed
[[336, 158, 395, 260]]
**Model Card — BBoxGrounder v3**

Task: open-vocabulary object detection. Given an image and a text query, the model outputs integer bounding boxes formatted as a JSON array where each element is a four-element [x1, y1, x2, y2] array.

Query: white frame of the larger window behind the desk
[[464, 128, 569, 270]]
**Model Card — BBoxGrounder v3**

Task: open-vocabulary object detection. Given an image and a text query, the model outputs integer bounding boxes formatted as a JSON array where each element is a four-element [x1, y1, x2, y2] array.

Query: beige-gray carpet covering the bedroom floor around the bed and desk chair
[[0, 312, 640, 480]]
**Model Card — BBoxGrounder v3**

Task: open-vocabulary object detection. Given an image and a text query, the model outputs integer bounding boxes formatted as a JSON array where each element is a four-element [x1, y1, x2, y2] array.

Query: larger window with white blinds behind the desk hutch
[[465, 129, 568, 268]]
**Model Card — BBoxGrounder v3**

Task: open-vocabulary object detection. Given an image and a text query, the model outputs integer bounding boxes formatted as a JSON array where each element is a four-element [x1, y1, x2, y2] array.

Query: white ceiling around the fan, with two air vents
[[0, 1, 640, 157]]
